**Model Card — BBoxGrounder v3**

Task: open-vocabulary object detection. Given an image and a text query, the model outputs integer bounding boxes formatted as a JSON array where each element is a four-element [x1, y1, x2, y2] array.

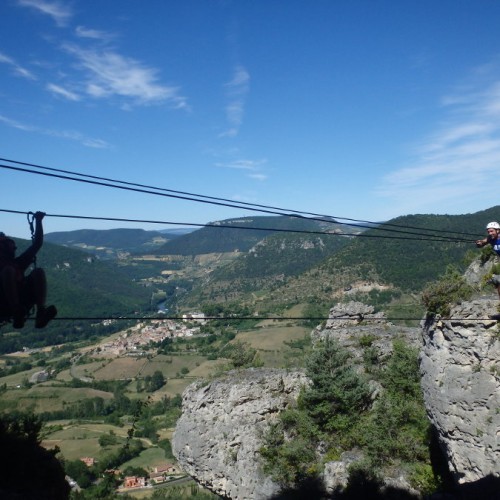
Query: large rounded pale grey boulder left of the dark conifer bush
[[172, 369, 307, 499]]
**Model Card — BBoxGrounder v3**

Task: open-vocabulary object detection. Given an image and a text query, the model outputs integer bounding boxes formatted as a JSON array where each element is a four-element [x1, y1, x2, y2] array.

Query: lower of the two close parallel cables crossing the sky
[[0, 164, 480, 242]]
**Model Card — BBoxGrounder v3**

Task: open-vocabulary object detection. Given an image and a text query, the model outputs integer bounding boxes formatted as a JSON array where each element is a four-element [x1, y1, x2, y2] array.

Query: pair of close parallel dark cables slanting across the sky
[[0, 158, 484, 241]]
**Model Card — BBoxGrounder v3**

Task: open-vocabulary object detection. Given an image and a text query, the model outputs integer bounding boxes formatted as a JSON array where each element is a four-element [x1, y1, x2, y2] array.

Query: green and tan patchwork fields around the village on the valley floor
[[0, 316, 310, 488]]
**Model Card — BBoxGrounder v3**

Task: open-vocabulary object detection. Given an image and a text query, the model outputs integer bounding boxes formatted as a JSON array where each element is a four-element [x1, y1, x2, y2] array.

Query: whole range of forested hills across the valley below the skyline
[[5, 206, 500, 352]]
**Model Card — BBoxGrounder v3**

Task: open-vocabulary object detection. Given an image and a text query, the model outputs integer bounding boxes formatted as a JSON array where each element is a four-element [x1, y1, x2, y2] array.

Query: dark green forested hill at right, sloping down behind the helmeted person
[[241, 206, 500, 306]]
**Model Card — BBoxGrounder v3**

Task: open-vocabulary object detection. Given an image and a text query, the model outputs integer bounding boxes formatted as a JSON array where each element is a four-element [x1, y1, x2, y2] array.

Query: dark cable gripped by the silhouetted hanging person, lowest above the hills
[[0, 209, 471, 243]]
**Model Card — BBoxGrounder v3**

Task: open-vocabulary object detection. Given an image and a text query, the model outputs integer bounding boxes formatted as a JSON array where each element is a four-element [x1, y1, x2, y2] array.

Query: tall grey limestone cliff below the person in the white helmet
[[420, 299, 500, 483]]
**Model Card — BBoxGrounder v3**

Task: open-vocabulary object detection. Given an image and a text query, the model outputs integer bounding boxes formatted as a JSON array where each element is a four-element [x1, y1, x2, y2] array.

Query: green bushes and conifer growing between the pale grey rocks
[[261, 340, 437, 492]]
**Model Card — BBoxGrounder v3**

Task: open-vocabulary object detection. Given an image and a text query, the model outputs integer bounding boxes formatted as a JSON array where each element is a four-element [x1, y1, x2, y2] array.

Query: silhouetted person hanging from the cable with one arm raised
[[0, 212, 57, 328]]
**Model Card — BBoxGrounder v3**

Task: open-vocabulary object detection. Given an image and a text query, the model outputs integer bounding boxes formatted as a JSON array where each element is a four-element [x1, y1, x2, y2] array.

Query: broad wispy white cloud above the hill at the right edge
[[376, 72, 500, 213]]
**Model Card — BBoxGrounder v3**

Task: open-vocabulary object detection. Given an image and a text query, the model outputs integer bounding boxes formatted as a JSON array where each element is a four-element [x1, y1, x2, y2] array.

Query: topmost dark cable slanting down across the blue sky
[[0, 158, 484, 238]]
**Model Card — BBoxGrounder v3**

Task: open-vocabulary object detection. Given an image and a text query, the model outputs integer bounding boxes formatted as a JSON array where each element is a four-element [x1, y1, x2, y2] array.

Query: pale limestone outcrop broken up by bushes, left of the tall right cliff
[[172, 302, 420, 500]]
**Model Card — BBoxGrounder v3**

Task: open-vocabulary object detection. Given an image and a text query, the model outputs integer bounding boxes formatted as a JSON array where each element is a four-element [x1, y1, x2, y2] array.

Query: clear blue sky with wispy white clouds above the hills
[[0, 0, 500, 237]]
